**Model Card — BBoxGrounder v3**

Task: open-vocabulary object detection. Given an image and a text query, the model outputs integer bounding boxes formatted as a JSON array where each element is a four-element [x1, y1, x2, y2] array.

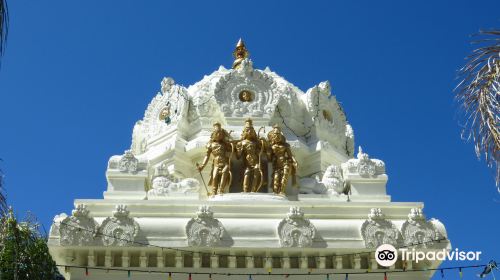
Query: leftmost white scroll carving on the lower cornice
[[59, 204, 97, 246]]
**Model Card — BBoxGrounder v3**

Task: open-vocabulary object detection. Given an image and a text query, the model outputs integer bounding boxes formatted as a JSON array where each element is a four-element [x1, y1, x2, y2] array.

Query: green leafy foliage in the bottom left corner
[[0, 211, 61, 280]]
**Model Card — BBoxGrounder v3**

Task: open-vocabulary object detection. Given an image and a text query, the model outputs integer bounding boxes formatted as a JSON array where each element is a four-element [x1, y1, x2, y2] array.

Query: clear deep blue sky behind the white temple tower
[[0, 0, 500, 275]]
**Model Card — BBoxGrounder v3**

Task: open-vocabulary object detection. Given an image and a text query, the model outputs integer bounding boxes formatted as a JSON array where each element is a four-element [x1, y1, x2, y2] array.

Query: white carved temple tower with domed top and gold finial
[[48, 40, 451, 280]]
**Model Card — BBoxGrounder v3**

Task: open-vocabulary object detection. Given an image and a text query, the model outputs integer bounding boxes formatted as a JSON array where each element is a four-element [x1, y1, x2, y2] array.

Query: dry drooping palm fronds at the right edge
[[456, 29, 500, 191]]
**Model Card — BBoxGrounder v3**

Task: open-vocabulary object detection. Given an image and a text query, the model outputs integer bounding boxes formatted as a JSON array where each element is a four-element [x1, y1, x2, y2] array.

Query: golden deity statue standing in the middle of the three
[[236, 119, 265, 192]]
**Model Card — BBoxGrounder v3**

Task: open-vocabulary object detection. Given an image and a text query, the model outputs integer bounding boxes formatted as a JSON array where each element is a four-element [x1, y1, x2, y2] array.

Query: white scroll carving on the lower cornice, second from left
[[100, 205, 139, 246]]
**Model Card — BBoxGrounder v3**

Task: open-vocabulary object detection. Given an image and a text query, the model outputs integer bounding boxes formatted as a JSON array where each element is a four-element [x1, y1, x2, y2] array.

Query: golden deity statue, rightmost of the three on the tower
[[267, 125, 298, 195]]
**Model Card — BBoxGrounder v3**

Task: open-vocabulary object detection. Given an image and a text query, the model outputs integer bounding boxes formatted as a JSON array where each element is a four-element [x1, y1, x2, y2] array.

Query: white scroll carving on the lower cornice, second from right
[[361, 208, 401, 248]]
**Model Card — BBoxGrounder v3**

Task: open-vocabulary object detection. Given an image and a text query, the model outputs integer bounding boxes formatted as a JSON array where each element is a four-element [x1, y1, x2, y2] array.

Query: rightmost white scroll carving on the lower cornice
[[401, 208, 442, 248]]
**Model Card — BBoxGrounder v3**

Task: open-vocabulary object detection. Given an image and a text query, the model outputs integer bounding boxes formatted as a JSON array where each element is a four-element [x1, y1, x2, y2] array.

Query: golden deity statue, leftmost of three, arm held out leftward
[[196, 123, 234, 196]]
